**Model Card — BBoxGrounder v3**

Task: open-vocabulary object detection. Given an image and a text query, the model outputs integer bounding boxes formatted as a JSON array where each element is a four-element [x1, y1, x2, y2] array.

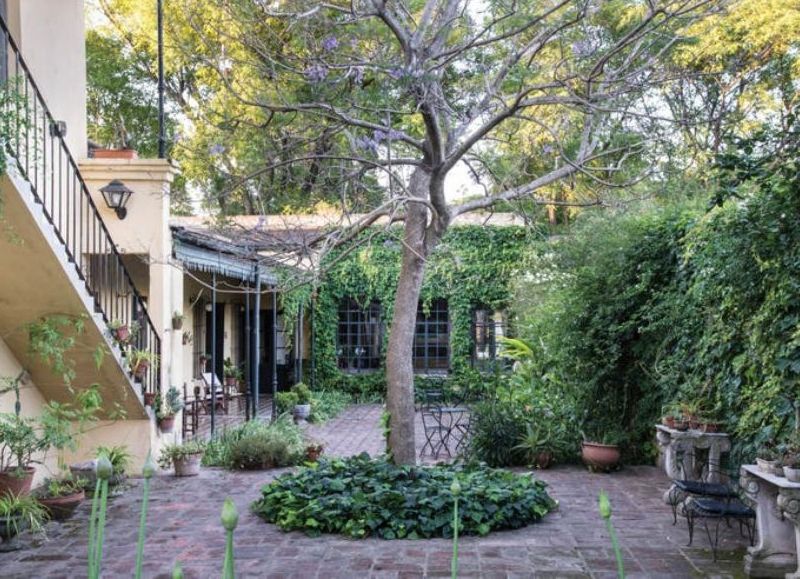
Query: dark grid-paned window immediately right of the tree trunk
[[414, 299, 450, 373]]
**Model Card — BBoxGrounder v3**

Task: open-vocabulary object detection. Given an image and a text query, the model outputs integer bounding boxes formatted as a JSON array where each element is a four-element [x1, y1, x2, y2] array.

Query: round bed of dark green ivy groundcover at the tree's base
[[253, 454, 557, 539]]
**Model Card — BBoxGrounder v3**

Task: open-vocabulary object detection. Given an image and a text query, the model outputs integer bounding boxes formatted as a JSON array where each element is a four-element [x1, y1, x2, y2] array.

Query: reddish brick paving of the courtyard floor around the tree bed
[[0, 406, 745, 579]]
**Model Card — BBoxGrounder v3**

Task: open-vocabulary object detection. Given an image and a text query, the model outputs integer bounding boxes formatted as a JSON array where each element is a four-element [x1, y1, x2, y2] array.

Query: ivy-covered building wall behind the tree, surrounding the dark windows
[[294, 225, 534, 397]]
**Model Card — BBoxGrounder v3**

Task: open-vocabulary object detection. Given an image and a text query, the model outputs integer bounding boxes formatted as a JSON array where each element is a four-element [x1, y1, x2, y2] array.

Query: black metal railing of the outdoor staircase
[[0, 17, 161, 402]]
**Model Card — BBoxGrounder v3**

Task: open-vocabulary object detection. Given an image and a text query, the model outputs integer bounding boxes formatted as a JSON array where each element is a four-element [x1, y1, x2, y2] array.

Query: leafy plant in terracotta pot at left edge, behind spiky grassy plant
[[0, 413, 50, 496]]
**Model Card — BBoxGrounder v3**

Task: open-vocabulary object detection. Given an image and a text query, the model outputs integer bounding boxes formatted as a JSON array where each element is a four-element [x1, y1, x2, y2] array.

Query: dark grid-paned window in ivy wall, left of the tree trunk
[[336, 299, 383, 372]]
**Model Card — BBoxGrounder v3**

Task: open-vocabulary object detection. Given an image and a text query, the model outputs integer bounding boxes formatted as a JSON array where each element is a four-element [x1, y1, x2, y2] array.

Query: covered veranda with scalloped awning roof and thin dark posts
[[173, 227, 303, 438]]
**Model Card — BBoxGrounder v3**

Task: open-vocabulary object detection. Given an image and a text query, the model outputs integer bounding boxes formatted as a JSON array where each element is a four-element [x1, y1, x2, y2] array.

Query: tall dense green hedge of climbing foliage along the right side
[[518, 165, 800, 460]]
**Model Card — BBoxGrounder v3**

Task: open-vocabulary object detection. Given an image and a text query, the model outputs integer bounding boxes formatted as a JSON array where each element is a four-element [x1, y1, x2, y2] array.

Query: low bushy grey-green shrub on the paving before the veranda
[[203, 415, 305, 469]]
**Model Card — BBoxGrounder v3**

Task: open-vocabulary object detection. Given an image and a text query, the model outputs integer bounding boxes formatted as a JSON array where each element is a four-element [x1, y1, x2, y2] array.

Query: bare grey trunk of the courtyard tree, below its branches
[[386, 169, 430, 464]]
